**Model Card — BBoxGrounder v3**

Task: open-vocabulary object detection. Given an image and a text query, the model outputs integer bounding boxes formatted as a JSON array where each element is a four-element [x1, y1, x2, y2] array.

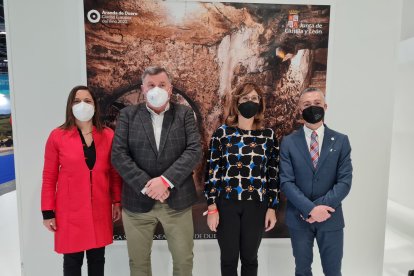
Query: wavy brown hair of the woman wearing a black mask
[[226, 82, 266, 129]]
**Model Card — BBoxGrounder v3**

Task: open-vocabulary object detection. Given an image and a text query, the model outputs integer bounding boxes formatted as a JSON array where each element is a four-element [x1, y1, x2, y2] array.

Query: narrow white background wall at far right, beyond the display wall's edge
[[389, 0, 414, 209]]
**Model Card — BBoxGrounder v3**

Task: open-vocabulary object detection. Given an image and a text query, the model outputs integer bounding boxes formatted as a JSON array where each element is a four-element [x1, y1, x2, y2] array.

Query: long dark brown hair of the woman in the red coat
[[60, 85, 104, 131]]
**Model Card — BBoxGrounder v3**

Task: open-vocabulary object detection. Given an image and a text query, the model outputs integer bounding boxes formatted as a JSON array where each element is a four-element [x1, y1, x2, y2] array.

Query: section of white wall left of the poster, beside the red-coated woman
[[5, 0, 86, 275]]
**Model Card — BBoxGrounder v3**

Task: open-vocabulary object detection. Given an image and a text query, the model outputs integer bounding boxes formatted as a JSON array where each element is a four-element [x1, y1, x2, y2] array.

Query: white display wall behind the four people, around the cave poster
[[6, 0, 401, 276]]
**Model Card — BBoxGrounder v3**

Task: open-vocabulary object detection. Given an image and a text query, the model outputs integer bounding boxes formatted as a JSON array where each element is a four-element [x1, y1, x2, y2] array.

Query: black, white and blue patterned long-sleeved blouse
[[204, 125, 279, 209]]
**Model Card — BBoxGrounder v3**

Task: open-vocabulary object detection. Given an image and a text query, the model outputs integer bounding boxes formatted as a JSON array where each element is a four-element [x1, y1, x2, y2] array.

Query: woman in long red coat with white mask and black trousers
[[41, 86, 121, 276]]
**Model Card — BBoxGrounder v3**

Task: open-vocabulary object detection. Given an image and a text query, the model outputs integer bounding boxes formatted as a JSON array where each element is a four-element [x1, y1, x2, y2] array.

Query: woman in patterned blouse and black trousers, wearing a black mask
[[205, 83, 279, 276]]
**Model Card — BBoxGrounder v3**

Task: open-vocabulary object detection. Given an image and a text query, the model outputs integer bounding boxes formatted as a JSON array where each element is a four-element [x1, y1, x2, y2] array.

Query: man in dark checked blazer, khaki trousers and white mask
[[112, 67, 201, 276]]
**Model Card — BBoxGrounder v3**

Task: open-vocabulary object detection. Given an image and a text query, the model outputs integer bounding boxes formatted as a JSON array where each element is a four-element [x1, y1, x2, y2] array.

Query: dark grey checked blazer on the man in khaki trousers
[[112, 103, 201, 213]]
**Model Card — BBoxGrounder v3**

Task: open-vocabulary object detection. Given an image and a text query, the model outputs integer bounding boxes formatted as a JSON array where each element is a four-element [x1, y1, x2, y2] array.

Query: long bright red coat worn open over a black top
[[41, 128, 121, 253]]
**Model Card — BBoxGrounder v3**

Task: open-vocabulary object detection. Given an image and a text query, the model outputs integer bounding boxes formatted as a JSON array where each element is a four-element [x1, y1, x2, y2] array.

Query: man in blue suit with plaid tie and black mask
[[280, 88, 352, 276]]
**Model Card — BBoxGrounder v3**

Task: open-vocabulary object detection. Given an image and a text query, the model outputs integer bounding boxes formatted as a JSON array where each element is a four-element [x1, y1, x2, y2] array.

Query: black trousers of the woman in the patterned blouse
[[217, 198, 267, 276]]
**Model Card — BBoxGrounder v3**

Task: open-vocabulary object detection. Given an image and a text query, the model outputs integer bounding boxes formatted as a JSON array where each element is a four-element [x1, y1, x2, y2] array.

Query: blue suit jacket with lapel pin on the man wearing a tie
[[280, 126, 352, 231]]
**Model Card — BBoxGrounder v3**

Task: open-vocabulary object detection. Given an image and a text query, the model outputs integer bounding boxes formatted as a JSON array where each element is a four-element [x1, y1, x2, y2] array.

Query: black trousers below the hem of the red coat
[[63, 247, 105, 276]]
